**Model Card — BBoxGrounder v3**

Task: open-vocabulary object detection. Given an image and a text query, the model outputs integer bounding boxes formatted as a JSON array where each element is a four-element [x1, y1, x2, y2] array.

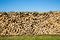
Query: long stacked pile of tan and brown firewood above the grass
[[0, 11, 60, 35]]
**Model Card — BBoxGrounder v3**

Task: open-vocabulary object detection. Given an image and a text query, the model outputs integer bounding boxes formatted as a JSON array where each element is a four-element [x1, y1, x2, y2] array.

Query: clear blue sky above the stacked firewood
[[0, 0, 60, 11]]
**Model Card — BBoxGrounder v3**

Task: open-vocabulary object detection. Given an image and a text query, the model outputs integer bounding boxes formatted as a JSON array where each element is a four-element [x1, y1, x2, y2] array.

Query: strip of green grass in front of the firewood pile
[[0, 35, 60, 40]]
